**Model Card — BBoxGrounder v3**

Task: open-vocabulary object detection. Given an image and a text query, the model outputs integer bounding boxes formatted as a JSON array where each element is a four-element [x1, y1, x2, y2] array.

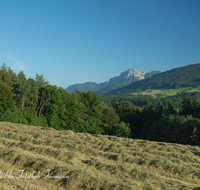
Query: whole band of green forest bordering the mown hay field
[[0, 64, 200, 145]]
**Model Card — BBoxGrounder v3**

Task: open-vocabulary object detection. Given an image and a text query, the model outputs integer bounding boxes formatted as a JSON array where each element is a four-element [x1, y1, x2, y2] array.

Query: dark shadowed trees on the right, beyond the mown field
[[110, 98, 200, 145]]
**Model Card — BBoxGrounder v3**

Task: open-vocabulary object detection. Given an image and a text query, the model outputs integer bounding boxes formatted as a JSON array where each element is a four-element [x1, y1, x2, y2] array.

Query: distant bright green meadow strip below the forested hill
[[132, 87, 200, 97]]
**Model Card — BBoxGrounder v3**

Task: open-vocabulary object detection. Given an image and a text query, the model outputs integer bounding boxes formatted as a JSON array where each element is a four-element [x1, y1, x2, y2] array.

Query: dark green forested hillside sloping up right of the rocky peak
[[105, 63, 200, 95]]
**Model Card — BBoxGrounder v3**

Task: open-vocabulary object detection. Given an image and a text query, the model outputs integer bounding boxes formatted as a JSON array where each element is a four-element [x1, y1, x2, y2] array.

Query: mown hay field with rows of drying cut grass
[[0, 122, 200, 190]]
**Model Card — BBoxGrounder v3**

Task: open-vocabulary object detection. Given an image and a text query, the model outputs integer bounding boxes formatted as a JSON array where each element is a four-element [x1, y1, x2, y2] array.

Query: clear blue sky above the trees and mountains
[[0, 0, 200, 88]]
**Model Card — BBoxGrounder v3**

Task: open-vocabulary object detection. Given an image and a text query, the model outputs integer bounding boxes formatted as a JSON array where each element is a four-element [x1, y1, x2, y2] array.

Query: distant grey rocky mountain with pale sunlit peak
[[65, 69, 162, 93]]
